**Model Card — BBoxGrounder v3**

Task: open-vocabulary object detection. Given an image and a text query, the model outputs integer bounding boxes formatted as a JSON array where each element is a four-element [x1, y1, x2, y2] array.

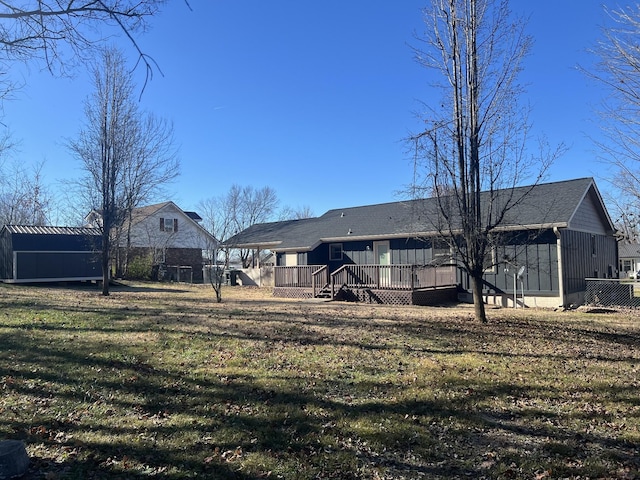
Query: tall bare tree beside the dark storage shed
[[68, 49, 178, 295]]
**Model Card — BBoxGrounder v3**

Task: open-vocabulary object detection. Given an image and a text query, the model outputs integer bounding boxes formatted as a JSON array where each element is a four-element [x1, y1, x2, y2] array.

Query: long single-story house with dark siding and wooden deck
[[224, 178, 618, 307]]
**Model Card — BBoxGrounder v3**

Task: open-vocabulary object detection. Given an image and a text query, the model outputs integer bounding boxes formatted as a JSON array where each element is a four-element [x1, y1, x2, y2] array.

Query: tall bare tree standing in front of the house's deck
[[410, 0, 559, 322]]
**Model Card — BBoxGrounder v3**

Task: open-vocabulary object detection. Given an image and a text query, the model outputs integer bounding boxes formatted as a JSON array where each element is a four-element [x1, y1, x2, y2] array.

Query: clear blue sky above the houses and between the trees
[[3, 0, 624, 223]]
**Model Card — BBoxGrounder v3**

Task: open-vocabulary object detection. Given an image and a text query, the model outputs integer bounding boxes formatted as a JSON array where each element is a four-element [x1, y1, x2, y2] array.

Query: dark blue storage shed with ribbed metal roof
[[0, 225, 102, 283]]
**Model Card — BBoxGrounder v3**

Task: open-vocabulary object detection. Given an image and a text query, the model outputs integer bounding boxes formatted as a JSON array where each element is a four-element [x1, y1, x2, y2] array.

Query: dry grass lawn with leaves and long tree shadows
[[0, 284, 640, 480]]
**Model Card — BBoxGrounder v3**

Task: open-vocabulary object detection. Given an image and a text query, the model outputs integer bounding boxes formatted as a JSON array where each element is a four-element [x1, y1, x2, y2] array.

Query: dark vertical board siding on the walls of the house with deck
[[278, 229, 618, 306]]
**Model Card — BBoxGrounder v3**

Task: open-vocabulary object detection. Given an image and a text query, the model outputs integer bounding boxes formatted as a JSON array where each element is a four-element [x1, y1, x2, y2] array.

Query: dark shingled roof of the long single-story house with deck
[[224, 178, 614, 251]]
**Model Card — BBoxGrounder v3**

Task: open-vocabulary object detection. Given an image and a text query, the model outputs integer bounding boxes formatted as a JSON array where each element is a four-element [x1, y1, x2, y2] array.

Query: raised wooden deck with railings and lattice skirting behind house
[[273, 265, 457, 305]]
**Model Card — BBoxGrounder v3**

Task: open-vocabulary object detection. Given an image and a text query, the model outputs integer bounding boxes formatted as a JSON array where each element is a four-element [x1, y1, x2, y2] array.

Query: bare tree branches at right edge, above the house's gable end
[[583, 4, 640, 216]]
